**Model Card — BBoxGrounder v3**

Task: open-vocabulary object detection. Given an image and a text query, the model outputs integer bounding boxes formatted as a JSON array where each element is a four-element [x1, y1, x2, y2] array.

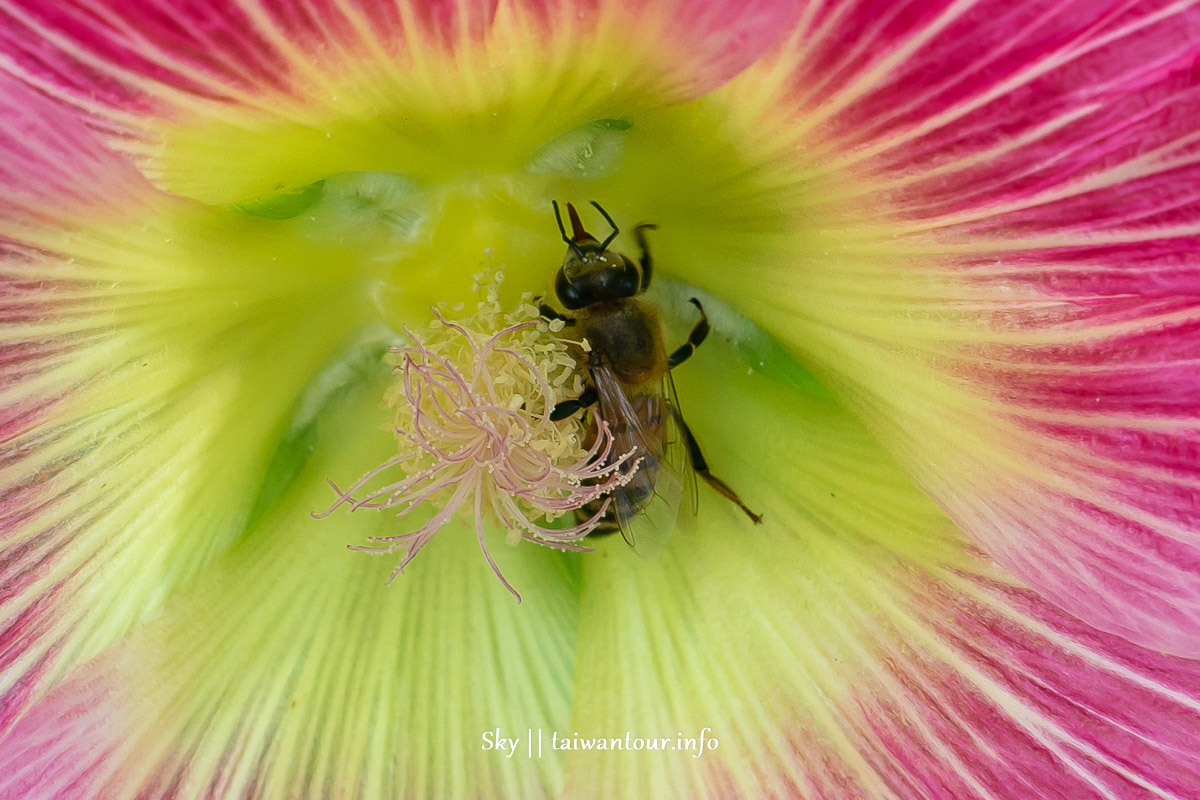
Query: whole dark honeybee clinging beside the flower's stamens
[[539, 201, 762, 555]]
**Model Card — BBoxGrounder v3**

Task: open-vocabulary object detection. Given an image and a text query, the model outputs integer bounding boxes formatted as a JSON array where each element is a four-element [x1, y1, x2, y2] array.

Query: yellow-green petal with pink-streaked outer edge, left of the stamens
[[0, 191, 362, 714]]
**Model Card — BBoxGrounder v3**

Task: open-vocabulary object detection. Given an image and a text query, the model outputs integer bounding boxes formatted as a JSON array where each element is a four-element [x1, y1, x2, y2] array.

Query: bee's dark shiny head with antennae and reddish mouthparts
[[554, 201, 642, 311]]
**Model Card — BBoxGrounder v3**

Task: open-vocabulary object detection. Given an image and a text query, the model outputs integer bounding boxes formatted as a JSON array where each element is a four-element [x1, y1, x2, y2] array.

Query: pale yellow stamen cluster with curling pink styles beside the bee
[[317, 273, 632, 600]]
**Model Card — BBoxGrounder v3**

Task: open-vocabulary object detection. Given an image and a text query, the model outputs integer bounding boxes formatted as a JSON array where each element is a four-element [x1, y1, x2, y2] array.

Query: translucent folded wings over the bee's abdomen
[[592, 365, 695, 558]]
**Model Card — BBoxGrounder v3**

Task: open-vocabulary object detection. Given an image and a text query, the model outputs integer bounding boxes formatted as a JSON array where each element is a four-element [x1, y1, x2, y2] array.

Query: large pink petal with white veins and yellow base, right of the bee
[[712, 0, 1200, 656]]
